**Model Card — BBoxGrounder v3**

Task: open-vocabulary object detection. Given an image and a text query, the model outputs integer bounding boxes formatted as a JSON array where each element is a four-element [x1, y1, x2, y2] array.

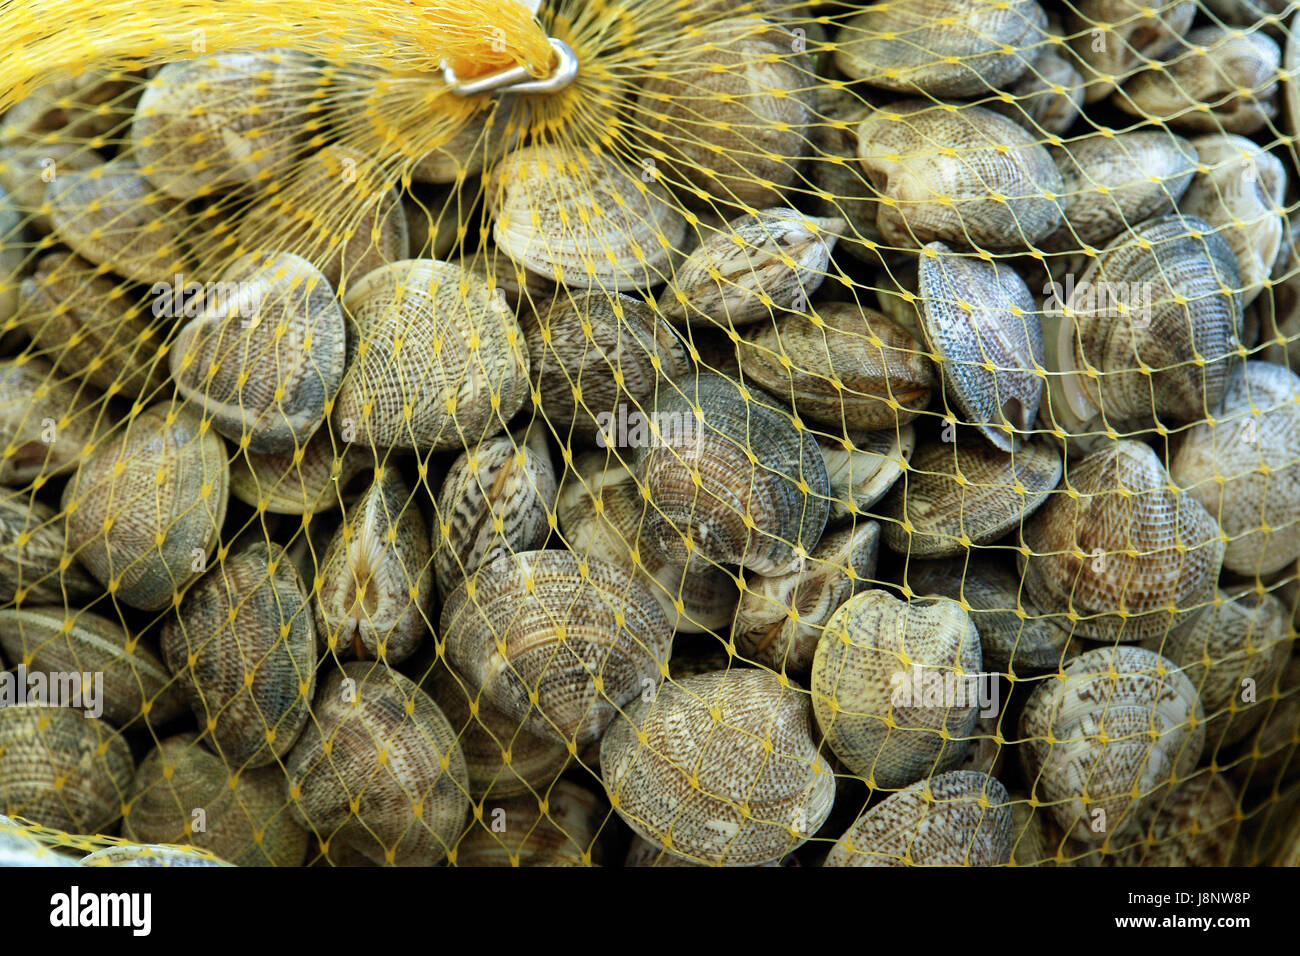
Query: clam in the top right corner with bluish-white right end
[[1113, 23, 1282, 134]]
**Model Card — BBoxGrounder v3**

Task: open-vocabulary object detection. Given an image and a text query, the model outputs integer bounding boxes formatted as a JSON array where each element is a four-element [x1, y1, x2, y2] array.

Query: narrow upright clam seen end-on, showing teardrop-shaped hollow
[[316, 463, 433, 663]]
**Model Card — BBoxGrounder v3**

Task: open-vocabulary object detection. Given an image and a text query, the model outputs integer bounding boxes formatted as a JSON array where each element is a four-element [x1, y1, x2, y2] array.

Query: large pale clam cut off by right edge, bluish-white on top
[[1169, 362, 1300, 575]]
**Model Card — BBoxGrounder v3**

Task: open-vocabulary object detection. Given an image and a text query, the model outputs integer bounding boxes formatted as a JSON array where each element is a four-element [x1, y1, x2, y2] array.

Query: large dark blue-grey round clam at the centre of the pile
[[633, 372, 831, 575]]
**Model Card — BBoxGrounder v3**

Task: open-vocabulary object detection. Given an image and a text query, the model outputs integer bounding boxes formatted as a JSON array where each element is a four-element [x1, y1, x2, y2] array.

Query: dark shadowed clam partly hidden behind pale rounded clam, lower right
[[907, 553, 1070, 675]]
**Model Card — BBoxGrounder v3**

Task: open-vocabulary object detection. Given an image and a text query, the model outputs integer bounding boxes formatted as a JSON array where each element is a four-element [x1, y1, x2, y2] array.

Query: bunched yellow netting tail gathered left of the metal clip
[[0, 0, 554, 109]]
